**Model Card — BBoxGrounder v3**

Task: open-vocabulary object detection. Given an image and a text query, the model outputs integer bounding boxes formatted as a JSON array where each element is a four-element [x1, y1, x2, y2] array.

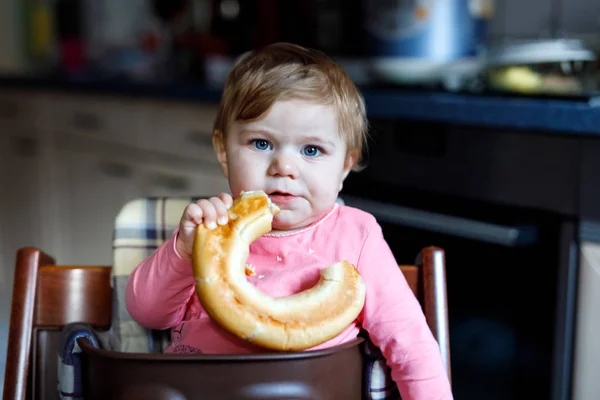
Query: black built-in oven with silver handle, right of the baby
[[342, 120, 579, 400]]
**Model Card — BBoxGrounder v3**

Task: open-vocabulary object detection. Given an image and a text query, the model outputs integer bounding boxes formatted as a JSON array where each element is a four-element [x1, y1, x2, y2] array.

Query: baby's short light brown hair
[[214, 43, 368, 170]]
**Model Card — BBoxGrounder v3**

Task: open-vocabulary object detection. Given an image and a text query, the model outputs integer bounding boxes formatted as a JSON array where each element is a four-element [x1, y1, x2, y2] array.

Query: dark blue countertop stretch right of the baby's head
[[365, 89, 600, 136]]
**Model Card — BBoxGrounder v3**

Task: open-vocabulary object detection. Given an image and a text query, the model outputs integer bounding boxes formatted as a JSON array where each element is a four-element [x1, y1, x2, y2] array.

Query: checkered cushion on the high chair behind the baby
[[110, 197, 399, 399]]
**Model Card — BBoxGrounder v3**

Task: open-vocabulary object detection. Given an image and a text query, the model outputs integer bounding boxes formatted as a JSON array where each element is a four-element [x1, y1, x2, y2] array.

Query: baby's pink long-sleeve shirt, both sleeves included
[[126, 204, 452, 400]]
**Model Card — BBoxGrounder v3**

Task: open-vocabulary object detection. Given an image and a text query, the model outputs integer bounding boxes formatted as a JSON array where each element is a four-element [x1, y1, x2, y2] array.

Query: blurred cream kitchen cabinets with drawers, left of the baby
[[0, 91, 228, 268]]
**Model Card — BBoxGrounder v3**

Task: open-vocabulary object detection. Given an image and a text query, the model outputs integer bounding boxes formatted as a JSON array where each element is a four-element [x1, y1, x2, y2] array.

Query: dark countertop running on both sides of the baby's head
[[0, 77, 600, 137]]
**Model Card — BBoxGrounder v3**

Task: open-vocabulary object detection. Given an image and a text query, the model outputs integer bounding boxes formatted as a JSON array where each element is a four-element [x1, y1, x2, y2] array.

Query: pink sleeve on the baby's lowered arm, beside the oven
[[358, 223, 453, 400]]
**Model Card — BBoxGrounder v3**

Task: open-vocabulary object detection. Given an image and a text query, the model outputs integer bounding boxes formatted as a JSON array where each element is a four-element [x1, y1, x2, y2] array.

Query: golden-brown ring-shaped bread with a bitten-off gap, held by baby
[[192, 191, 365, 351]]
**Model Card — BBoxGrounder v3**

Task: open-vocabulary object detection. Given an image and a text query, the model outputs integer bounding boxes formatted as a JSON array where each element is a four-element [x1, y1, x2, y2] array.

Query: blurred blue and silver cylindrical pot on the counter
[[365, 0, 494, 84]]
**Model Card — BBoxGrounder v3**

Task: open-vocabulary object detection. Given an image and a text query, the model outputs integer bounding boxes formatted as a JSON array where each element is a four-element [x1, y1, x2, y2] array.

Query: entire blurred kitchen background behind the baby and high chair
[[0, 0, 600, 400]]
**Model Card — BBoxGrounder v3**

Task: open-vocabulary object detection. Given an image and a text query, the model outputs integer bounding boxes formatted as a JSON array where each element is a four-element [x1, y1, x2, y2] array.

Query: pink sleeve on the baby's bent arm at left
[[125, 231, 196, 330]]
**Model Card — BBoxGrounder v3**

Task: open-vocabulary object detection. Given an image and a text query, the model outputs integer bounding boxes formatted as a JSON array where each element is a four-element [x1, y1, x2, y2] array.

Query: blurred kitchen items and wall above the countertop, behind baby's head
[[0, 0, 600, 94]]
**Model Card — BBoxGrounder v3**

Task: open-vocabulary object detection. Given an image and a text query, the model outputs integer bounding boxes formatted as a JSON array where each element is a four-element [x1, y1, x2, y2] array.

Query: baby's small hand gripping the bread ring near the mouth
[[176, 193, 233, 261]]
